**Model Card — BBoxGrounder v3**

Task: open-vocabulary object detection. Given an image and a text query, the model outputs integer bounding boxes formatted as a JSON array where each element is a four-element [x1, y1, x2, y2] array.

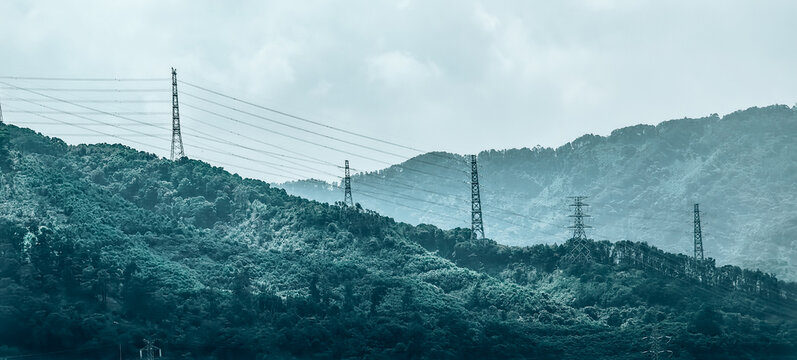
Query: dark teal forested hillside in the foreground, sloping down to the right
[[0, 125, 797, 359]]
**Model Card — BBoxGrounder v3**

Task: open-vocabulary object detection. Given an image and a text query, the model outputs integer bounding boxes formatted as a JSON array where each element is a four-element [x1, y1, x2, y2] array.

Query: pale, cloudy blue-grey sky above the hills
[[0, 0, 797, 181]]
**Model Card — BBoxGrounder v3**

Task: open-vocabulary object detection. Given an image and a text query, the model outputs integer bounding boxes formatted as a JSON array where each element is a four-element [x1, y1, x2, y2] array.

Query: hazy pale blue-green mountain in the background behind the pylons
[[283, 106, 797, 280]]
